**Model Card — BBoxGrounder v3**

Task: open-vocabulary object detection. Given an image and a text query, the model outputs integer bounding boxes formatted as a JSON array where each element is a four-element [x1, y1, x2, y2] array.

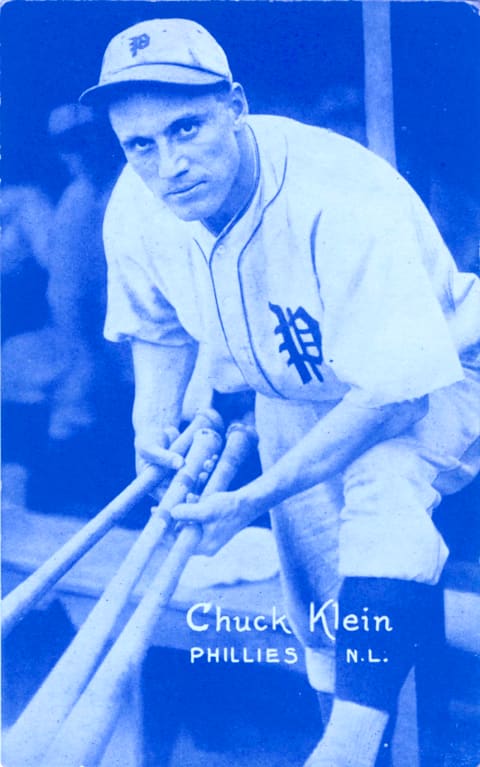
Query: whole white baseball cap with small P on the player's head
[[80, 19, 232, 103]]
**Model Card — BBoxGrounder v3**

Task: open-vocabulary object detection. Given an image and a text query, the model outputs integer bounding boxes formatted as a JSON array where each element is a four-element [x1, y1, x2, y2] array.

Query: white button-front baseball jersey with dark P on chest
[[104, 116, 480, 406]]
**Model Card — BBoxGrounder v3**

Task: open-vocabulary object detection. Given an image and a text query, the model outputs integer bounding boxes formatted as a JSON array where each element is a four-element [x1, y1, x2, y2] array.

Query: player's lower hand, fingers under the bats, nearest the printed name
[[170, 491, 261, 557]]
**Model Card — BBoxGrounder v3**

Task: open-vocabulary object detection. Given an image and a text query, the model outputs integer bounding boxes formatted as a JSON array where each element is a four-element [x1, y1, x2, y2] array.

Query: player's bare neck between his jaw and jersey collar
[[202, 126, 257, 237]]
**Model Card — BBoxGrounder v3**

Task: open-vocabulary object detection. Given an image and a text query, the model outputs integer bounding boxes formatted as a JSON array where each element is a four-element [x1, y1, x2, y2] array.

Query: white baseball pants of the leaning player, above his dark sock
[[256, 371, 480, 689]]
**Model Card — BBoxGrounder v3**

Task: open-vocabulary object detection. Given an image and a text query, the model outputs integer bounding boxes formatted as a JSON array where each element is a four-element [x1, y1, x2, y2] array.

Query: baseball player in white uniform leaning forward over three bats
[[82, 19, 480, 767]]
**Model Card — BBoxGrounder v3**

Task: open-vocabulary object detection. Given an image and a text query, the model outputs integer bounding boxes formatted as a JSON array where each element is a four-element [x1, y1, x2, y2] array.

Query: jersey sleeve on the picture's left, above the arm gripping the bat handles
[[103, 177, 192, 346]]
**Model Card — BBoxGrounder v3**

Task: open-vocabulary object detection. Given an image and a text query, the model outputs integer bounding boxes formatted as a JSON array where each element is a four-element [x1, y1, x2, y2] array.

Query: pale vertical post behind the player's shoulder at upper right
[[362, 0, 396, 167]]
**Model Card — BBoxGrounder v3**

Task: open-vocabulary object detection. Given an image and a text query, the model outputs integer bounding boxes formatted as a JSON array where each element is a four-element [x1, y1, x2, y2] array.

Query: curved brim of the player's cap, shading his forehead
[[79, 64, 231, 105]]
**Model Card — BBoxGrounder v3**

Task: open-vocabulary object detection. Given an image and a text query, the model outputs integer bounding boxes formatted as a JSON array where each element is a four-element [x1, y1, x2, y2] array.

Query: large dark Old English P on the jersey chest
[[268, 303, 323, 383]]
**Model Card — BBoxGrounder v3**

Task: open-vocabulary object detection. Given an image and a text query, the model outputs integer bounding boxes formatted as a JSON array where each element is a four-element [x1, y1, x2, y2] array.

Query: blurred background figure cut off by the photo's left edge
[[0, 185, 55, 506]]
